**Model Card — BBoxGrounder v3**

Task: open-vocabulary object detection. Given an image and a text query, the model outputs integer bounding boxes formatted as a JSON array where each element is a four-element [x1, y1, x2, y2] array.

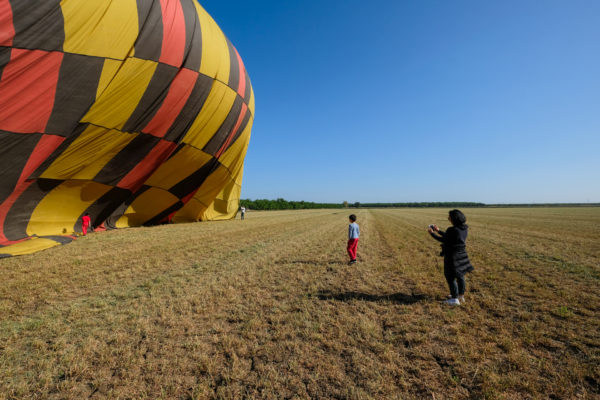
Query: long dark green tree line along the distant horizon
[[240, 198, 600, 211]]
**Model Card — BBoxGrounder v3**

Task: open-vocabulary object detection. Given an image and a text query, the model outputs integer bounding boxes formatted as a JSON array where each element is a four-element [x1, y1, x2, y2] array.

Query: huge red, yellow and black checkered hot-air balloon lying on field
[[0, 0, 254, 257]]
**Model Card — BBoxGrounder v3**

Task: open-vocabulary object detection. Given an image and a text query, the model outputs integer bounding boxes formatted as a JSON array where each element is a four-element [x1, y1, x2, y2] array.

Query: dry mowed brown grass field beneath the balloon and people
[[0, 208, 600, 399]]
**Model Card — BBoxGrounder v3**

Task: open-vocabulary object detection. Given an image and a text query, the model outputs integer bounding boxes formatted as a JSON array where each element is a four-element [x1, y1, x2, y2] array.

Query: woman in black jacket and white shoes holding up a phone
[[427, 210, 473, 306]]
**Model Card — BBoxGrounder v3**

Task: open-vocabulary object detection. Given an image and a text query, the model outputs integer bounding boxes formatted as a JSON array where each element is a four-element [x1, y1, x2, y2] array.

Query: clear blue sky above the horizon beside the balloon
[[200, 0, 600, 203]]
